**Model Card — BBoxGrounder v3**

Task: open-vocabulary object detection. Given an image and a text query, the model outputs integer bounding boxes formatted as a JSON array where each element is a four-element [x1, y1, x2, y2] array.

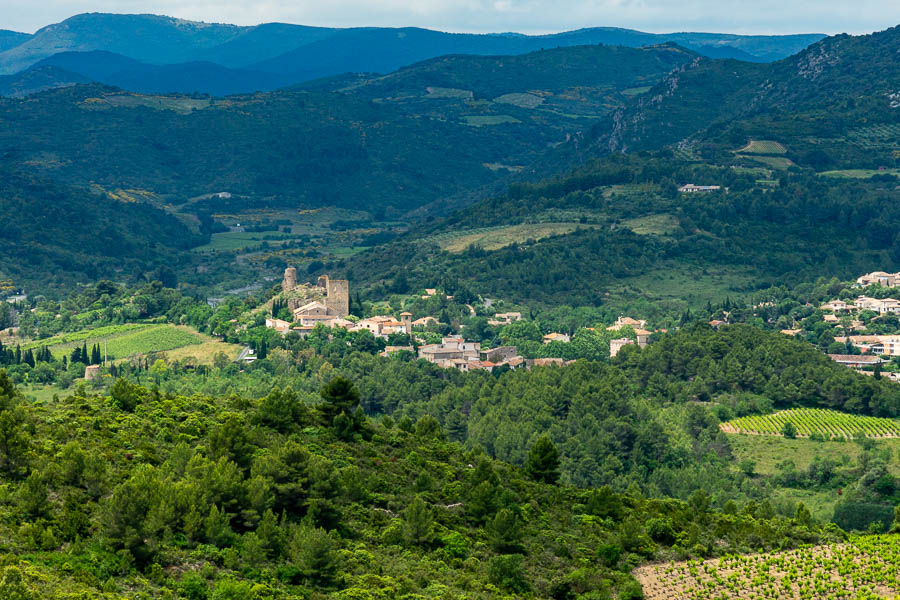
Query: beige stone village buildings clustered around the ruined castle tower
[[265, 267, 653, 371]]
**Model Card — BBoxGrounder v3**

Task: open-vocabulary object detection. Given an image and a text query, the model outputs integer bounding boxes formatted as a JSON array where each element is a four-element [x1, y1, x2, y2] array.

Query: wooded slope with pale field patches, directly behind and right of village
[[329, 151, 900, 306]]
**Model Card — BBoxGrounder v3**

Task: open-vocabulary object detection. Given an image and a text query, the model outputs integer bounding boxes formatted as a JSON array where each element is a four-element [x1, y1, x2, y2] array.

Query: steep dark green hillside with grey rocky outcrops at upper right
[[598, 27, 900, 170]]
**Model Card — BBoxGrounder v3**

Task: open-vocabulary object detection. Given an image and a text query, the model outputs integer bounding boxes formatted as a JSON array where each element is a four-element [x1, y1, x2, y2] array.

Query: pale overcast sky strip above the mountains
[[0, 0, 900, 34]]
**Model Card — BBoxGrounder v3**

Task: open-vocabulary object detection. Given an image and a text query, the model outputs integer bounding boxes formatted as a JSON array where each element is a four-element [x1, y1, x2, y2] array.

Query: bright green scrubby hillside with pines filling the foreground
[[0, 371, 842, 600]]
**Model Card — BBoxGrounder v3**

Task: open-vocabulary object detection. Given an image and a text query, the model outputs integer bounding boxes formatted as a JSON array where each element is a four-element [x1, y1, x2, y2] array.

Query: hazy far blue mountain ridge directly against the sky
[[0, 13, 824, 79]]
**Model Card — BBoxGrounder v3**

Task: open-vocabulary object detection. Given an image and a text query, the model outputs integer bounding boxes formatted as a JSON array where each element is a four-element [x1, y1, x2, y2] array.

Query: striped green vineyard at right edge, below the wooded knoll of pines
[[720, 408, 900, 439]]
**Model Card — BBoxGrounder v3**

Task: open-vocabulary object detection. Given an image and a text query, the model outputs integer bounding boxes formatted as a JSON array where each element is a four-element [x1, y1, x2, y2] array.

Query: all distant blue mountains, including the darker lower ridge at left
[[0, 13, 824, 96]]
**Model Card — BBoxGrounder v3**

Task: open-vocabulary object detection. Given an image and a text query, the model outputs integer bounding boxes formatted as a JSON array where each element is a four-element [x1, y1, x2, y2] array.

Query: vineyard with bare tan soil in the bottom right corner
[[634, 535, 900, 600]]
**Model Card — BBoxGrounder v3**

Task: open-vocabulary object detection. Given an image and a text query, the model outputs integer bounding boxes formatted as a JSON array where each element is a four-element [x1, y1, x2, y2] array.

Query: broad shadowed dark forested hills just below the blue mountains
[[0, 47, 693, 214]]
